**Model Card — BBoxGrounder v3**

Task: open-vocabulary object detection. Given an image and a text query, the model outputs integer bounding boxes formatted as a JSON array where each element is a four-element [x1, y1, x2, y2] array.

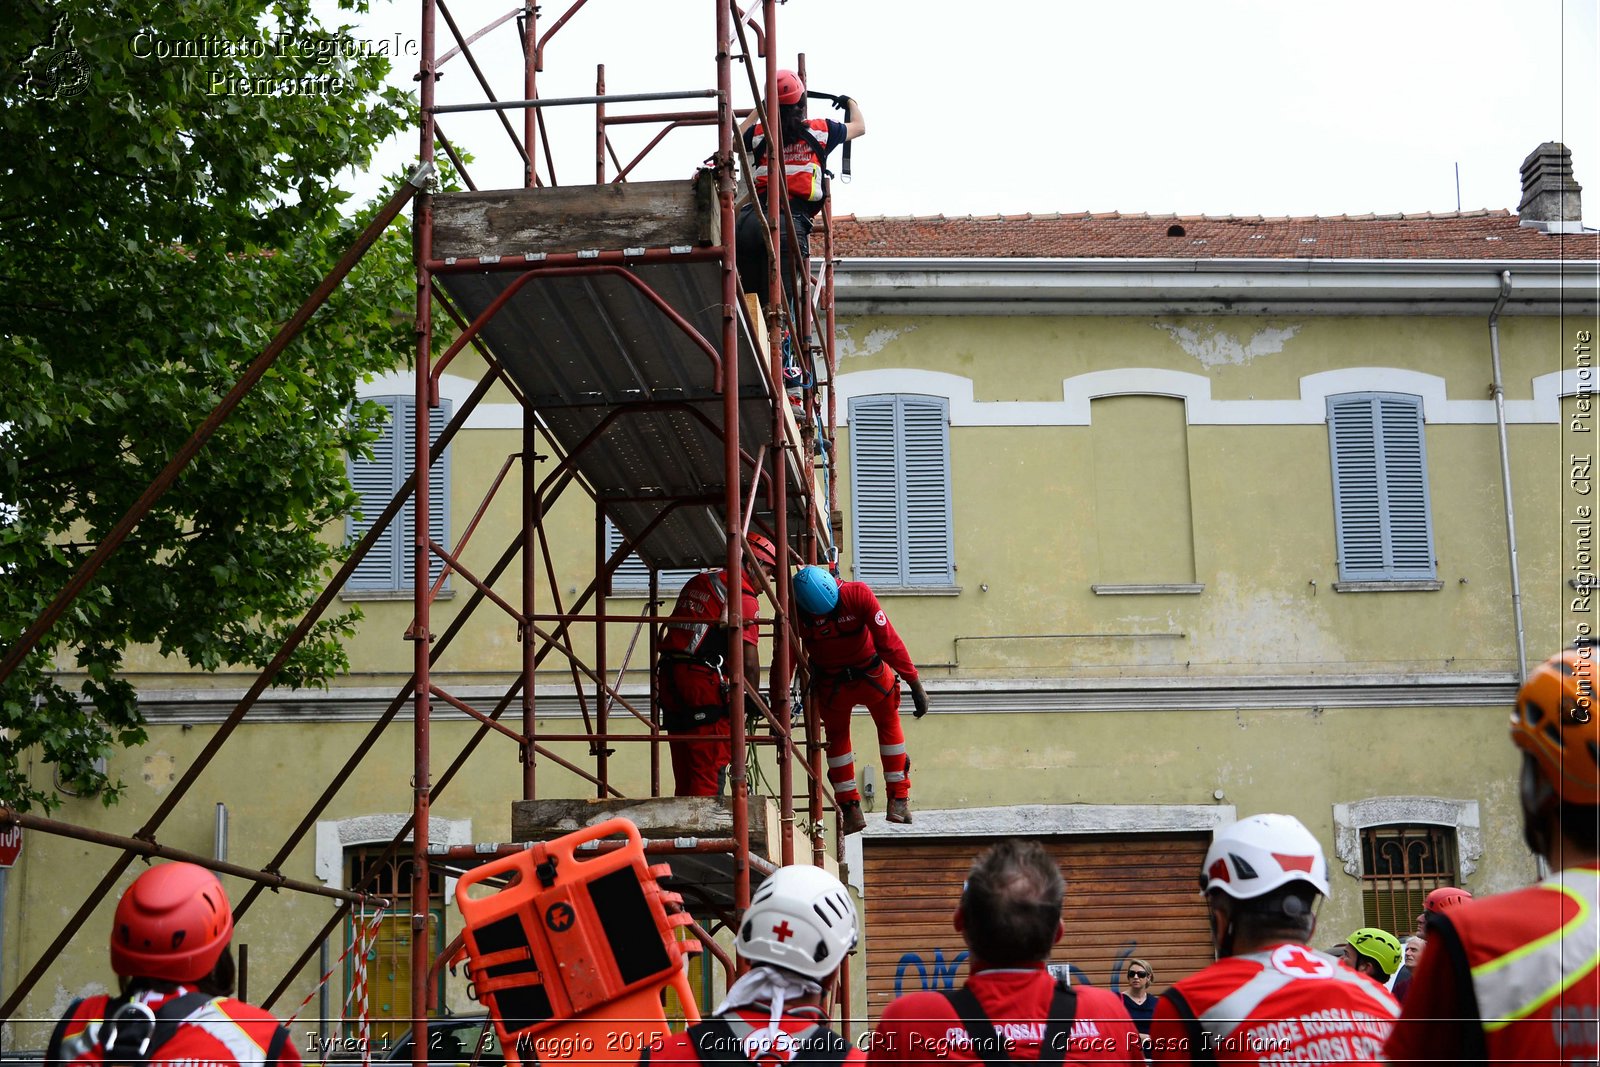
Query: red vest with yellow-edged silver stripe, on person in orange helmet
[[1384, 867, 1600, 1064]]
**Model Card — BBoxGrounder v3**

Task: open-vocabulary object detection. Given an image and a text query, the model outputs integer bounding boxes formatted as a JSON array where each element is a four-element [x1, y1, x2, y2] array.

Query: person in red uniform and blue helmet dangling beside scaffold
[[794, 566, 928, 833]]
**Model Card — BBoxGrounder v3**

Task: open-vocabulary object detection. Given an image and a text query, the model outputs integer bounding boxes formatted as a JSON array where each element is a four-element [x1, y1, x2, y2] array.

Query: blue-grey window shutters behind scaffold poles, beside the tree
[[346, 397, 450, 590]]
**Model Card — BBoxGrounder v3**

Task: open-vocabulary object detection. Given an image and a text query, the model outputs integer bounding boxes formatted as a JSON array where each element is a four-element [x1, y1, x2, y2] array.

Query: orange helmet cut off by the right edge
[[1510, 645, 1600, 806]]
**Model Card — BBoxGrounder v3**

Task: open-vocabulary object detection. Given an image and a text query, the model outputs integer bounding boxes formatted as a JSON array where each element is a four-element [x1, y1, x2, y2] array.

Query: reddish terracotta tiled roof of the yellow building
[[834, 211, 1600, 259]]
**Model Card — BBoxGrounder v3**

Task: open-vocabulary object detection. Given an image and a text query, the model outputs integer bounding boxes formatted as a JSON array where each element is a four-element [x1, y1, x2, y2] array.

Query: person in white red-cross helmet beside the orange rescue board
[[640, 864, 866, 1067]]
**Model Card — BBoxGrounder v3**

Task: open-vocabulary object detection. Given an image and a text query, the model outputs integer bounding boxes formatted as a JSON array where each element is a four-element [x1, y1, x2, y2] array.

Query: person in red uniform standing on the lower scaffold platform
[[656, 534, 778, 797]]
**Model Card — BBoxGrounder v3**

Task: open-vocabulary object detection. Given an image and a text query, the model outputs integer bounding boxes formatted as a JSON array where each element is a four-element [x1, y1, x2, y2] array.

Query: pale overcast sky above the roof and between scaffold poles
[[331, 0, 1600, 224]]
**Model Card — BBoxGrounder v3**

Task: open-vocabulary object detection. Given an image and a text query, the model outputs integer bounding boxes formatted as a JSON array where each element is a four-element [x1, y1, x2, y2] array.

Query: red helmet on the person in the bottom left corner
[[110, 864, 234, 982]]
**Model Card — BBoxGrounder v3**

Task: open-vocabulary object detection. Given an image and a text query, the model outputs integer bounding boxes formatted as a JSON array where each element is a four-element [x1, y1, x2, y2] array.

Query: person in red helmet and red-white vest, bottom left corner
[[45, 864, 301, 1067]]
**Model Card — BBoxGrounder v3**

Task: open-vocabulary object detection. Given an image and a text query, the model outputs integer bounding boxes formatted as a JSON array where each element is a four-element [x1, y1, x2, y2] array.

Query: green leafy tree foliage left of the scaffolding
[[0, 0, 413, 808]]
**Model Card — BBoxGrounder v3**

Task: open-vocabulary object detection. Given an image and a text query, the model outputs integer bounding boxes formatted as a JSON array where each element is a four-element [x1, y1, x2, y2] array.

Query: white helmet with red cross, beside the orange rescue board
[[739, 864, 856, 979]]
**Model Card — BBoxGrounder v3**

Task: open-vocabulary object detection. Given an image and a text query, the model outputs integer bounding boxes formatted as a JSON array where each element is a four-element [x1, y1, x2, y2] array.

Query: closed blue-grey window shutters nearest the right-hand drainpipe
[[1328, 394, 1435, 581]]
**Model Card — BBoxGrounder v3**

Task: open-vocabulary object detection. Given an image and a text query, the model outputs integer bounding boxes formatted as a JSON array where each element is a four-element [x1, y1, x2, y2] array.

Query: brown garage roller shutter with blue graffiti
[[862, 832, 1213, 1019]]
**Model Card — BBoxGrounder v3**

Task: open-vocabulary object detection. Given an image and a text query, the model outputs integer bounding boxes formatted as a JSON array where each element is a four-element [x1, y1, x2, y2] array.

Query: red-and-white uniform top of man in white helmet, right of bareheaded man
[[1150, 942, 1400, 1064]]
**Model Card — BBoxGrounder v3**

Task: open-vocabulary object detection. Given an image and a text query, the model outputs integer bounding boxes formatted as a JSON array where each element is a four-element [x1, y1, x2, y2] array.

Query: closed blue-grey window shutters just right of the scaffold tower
[[850, 395, 955, 589]]
